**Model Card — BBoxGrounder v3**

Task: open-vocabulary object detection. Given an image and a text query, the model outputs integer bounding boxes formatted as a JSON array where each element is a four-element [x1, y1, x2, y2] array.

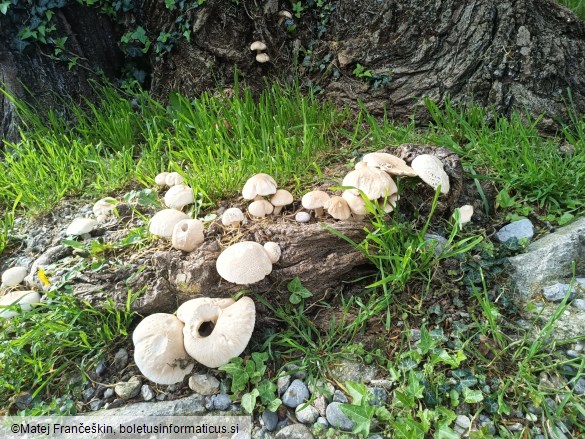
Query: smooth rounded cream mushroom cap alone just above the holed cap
[[215, 241, 272, 285]]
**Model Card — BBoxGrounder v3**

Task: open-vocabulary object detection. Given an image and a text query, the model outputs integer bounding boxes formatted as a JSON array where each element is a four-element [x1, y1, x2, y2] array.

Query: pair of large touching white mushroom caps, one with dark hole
[[132, 297, 256, 384]]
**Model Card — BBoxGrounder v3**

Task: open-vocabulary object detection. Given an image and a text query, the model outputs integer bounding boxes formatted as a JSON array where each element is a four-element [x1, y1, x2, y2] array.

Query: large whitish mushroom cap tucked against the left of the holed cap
[[132, 313, 193, 384]]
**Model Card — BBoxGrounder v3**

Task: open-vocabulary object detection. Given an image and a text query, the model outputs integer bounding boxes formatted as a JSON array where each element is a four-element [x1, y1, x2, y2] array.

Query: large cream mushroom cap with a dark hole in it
[[183, 297, 256, 367]]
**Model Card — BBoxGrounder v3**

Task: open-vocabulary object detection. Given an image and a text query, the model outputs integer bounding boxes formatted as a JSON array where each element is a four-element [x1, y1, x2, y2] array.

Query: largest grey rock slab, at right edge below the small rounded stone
[[508, 218, 585, 298]]
